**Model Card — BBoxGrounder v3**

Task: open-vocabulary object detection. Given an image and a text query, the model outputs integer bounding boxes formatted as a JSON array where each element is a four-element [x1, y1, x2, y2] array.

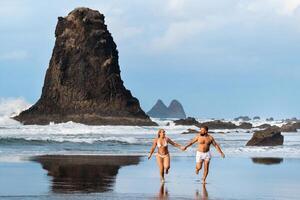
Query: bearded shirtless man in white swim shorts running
[[182, 126, 225, 184]]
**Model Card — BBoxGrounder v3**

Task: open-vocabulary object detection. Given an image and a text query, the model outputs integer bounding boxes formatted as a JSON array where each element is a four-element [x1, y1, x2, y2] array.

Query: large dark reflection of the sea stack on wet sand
[[32, 155, 140, 193]]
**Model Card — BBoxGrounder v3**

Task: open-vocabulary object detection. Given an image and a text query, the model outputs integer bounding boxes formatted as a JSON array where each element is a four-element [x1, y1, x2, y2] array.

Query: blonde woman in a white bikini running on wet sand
[[148, 129, 183, 182]]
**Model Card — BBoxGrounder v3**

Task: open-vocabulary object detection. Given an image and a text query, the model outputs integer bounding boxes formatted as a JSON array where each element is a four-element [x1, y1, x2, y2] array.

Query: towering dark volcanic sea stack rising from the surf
[[15, 8, 156, 125]]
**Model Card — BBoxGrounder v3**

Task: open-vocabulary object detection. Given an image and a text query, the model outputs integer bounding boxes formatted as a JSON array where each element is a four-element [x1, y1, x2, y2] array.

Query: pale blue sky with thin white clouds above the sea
[[0, 0, 300, 118]]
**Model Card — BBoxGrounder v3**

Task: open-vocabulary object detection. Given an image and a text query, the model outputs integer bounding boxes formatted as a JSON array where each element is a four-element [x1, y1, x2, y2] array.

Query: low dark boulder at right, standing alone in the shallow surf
[[246, 126, 283, 146]]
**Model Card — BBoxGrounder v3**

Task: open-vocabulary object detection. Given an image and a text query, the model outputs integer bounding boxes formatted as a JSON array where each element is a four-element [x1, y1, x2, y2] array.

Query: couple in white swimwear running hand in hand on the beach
[[148, 126, 225, 184]]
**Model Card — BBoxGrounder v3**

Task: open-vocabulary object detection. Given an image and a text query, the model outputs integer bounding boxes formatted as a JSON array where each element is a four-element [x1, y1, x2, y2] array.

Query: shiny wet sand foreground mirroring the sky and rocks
[[0, 155, 300, 199]]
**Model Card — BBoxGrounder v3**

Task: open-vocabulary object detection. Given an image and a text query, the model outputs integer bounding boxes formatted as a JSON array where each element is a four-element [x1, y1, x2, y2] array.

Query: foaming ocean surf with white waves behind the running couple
[[0, 99, 300, 162]]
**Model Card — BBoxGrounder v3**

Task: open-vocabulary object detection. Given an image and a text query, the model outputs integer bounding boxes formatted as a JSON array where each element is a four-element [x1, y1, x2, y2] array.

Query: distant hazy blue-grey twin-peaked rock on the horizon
[[147, 99, 186, 119]]
